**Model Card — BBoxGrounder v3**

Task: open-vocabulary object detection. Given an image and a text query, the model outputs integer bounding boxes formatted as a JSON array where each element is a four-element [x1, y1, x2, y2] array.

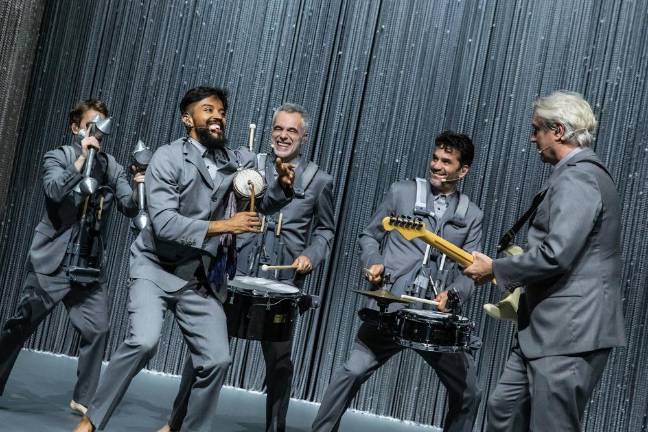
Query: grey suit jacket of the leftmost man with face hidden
[[29, 144, 138, 275]]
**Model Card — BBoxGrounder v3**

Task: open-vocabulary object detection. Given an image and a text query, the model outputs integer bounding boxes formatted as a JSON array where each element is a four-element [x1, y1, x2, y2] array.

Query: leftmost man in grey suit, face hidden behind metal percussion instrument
[[0, 99, 144, 414]]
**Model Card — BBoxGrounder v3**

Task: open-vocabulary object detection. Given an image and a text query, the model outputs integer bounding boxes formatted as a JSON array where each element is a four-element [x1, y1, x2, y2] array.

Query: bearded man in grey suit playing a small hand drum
[[75, 87, 294, 432]]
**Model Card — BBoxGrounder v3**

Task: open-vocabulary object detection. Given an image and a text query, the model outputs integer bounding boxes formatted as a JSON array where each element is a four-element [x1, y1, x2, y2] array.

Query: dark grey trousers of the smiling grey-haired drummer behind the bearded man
[[169, 341, 294, 432]]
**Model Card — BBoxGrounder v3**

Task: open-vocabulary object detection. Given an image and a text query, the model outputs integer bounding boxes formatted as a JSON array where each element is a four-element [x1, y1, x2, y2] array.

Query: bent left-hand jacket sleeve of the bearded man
[[144, 147, 209, 247]]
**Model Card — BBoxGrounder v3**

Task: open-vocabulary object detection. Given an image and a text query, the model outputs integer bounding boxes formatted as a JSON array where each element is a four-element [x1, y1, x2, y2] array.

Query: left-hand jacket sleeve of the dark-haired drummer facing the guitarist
[[358, 185, 396, 268]]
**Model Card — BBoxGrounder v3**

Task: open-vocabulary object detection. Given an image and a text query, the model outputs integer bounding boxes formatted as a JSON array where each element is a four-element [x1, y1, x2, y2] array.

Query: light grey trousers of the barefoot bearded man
[[88, 279, 231, 432]]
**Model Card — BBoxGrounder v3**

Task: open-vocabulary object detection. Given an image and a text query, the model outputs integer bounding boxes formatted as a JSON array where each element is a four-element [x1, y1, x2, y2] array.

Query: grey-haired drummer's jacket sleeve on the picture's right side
[[300, 177, 335, 269]]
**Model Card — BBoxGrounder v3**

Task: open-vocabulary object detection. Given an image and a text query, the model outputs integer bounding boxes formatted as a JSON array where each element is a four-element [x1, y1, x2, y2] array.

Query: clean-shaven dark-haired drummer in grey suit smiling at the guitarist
[[313, 132, 483, 432]]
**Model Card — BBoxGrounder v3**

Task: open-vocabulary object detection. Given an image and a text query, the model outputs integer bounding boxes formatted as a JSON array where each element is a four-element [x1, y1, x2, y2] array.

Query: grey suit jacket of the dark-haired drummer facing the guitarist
[[359, 181, 483, 308]]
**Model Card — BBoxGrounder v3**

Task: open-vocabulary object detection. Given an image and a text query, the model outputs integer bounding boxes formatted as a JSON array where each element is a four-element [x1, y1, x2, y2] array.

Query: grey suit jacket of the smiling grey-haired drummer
[[237, 158, 335, 286]]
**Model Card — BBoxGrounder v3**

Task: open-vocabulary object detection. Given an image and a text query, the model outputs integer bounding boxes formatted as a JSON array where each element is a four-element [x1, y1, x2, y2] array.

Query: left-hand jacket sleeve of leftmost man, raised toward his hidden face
[[43, 148, 83, 203]]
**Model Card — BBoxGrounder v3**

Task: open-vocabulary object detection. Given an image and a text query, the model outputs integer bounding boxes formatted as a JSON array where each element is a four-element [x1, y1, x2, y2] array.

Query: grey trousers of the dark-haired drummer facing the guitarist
[[312, 323, 482, 432]]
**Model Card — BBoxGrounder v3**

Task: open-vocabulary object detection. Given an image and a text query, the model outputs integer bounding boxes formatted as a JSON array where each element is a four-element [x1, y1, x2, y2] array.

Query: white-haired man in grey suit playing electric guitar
[[465, 91, 625, 432]]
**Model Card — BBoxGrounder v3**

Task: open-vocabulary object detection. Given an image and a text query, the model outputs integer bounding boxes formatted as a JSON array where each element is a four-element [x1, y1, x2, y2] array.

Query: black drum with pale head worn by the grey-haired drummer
[[224, 276, 301, 342]]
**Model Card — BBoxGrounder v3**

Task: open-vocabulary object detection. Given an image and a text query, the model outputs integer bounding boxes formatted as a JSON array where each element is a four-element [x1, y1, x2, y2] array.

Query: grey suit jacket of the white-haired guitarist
[[493, 149, 625, 358]]
